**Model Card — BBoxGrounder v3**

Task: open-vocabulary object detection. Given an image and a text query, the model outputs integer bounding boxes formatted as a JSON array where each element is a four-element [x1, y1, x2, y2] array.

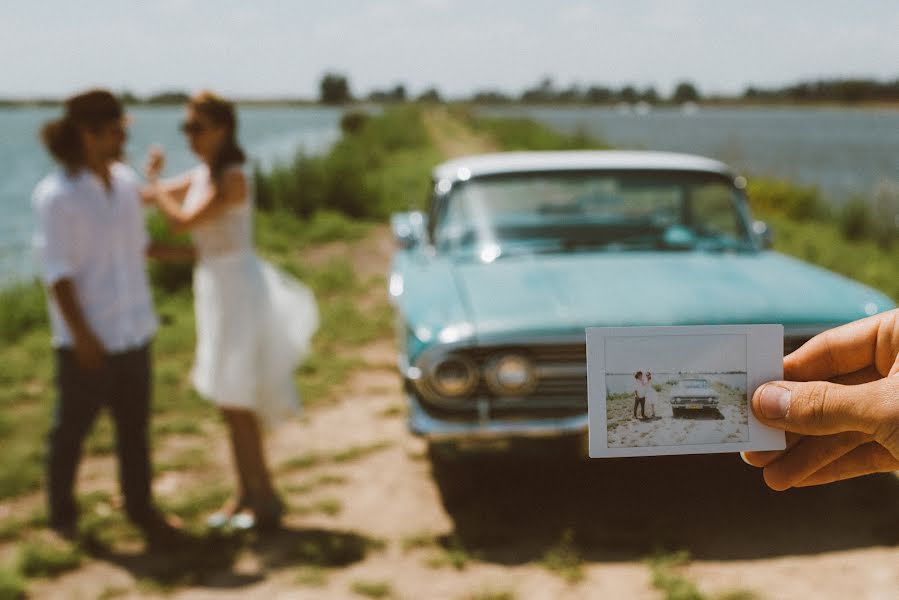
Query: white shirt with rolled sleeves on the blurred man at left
[[32, 163, 157, 352]]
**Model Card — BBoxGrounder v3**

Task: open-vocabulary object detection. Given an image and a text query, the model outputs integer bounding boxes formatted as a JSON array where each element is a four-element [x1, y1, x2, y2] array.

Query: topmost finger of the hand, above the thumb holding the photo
[[784, 315, 890, 381]]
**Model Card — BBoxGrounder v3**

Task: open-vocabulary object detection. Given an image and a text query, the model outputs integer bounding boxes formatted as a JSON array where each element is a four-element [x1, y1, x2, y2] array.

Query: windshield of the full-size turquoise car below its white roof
[[433, 171, 754, 257]]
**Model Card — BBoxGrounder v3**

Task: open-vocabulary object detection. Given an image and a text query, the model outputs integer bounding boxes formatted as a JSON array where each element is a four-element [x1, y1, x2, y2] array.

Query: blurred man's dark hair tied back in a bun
[[41, 90, 124, 172]]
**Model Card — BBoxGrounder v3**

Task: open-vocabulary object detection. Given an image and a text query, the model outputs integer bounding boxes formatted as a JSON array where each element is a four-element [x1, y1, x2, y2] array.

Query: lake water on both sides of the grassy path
[[0, 107, 899, 284]]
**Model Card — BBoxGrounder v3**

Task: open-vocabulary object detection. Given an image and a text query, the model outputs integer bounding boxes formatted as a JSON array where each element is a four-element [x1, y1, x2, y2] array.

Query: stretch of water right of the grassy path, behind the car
[[483, 107, 899, 203]]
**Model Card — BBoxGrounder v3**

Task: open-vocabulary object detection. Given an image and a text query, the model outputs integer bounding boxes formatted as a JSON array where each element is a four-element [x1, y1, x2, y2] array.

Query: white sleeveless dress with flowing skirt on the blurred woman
[[184, 165, 318, 425]]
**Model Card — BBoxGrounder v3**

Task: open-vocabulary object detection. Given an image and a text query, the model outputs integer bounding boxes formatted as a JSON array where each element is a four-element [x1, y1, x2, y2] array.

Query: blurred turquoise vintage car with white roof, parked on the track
[[389, 151, 894, 442]]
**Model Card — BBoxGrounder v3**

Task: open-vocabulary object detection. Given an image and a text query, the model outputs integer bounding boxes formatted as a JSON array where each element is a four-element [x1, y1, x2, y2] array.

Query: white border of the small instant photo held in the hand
[[587, 325, 786, 458]]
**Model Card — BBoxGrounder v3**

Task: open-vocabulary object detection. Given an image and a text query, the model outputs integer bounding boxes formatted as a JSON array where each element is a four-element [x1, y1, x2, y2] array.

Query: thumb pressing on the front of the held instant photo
[[752, 380, 884, 435]]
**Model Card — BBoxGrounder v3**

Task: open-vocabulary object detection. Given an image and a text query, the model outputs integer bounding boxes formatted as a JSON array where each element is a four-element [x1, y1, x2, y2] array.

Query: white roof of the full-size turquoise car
[[433, 150, 733, 181]]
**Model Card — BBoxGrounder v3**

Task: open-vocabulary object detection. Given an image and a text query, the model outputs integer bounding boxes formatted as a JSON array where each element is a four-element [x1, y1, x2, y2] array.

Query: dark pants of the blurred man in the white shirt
[[47, 346, 154, 527]]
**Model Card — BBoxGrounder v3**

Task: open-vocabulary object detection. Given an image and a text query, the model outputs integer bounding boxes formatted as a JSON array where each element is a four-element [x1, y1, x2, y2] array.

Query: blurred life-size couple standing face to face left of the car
[[32, 89, 318, 546]]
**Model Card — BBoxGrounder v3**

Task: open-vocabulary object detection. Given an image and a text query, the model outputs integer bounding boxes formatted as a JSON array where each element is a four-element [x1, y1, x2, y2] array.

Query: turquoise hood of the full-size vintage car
[[453, 251, 893, 338]]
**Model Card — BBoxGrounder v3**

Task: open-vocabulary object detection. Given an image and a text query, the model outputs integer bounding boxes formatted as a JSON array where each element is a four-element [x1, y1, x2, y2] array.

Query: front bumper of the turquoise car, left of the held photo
[[406, 394, 587, 442]]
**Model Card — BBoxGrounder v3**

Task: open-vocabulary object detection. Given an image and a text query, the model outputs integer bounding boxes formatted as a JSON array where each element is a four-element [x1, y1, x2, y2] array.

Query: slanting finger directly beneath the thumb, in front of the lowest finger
[[764, 431, 872, 490]]
